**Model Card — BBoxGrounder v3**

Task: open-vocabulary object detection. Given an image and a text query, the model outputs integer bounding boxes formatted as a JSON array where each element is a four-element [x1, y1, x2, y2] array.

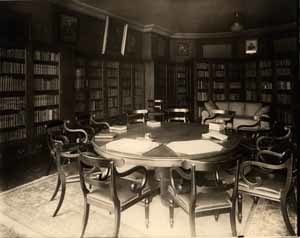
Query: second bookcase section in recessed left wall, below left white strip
[[87, 60, 105, 119]]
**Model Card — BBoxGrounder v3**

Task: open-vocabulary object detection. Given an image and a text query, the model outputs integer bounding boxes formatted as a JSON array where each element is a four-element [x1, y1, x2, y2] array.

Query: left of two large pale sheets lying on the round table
[[105, 138, 160, 155]]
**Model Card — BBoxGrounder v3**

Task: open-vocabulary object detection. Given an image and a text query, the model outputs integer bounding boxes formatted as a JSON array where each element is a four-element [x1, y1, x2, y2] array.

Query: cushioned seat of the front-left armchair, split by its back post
[[87, 179, 152, 207]]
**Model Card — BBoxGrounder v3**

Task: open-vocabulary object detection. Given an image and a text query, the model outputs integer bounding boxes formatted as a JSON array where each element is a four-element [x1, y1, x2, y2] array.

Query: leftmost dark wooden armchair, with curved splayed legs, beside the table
[[47, 121, 88, 217]]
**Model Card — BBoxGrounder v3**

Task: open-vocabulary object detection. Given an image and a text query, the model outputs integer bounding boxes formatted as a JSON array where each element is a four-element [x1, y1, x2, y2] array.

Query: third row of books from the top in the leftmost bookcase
[[0, 75, 26, 92]]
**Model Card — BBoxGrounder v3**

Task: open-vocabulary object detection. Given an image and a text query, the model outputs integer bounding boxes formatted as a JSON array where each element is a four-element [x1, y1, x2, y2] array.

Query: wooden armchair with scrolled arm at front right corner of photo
[[238, 139, 296, 235]]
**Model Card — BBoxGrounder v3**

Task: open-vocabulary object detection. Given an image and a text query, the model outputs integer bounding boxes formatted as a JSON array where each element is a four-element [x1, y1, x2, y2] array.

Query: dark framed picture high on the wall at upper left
[[59, 14, 79, 43]]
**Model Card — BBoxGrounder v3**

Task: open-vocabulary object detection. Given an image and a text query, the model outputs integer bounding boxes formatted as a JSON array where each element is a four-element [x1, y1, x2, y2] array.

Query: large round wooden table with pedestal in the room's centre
[[92, 122, 241, 204]]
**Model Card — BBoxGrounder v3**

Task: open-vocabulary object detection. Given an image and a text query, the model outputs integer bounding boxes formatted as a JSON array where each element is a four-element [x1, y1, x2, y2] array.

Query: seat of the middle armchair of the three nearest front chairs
[[169, 186, 232, 213]]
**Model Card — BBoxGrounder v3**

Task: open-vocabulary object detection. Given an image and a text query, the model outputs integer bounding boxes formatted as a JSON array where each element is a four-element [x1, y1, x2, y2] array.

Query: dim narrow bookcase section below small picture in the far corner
[[175, 64, 189, 107]]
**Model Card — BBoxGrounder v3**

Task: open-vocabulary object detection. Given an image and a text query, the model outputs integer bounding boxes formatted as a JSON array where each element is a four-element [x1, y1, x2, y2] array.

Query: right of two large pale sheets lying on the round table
[[167, 140, 223, 155]]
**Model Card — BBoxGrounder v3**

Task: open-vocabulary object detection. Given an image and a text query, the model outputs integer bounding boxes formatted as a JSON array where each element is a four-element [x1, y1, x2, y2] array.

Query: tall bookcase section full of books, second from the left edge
[[33, 49, 60, 136]]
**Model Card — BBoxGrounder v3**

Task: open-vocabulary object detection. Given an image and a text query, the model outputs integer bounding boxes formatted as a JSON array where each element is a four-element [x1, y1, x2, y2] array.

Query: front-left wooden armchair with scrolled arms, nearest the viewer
[[79, 152, 158, 237]]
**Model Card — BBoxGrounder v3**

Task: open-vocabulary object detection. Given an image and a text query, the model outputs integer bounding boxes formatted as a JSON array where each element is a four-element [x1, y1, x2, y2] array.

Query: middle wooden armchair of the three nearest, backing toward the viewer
[[168, 155, 239, 237]]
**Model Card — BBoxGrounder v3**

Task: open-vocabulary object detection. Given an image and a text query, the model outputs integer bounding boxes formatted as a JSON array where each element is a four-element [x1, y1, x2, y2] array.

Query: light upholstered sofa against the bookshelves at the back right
[[201, 101, 270, 129]]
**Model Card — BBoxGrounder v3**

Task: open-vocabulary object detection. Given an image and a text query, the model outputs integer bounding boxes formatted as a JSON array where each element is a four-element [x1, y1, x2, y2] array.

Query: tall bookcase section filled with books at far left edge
[[0, 48, 27, 145]]
